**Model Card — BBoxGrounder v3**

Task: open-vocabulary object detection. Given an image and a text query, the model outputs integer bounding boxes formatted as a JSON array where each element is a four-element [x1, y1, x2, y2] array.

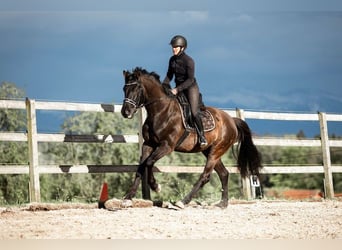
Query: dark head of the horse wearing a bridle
[[121, 70, 144, 119]]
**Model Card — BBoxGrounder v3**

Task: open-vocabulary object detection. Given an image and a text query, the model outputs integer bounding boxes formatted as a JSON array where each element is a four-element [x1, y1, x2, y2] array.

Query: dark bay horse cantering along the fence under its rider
[[121, 67, 262, 208]]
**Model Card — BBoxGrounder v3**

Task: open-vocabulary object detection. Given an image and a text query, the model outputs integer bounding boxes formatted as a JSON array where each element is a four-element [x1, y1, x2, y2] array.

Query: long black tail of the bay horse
[[233, 118, 262, 177]]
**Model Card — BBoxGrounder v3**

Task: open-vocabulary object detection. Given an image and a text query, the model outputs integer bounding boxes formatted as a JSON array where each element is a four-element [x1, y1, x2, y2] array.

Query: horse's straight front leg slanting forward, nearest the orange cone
[[124, 144, 153, 200]]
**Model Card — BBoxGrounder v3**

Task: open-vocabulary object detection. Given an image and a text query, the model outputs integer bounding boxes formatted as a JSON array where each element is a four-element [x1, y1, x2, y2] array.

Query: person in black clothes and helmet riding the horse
[[162, 35, 208, 147]]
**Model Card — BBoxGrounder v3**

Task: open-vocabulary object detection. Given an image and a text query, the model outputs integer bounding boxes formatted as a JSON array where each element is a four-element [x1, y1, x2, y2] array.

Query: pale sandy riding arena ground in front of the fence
[[0, 200, 342, 240]]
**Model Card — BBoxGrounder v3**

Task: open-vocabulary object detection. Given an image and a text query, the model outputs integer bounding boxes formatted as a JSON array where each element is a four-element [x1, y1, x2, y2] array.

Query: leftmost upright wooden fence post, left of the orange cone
[[26, 98, 40, 202]]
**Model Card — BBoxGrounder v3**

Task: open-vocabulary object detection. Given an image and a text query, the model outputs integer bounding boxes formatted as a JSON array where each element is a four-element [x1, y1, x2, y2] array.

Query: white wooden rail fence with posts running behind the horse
[[0, 99, 342, 202]]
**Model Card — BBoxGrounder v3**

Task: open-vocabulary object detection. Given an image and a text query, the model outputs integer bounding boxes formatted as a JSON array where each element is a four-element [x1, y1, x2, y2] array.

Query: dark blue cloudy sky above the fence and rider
[[0, 0, 342, 137]]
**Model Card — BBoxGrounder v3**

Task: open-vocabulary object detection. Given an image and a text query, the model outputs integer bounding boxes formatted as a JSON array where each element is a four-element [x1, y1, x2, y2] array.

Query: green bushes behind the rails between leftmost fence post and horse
[[39, 112, 140, 202]]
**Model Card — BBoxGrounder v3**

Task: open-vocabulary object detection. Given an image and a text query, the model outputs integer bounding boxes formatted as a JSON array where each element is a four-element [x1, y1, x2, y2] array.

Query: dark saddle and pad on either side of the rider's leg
[[177, 93, 215, 132]]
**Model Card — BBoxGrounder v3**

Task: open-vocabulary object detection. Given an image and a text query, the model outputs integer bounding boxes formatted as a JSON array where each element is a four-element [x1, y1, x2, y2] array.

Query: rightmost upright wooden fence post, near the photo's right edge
[[318, 112, 335, 199]]
